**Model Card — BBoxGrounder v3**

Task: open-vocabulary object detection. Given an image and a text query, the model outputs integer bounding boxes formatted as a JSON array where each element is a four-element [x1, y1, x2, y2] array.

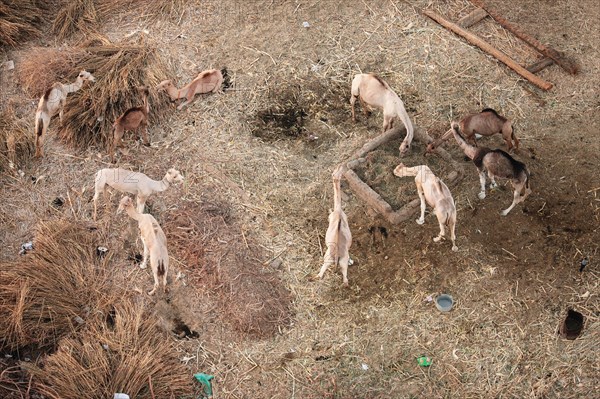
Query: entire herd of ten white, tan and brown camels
[[30, 69, 531, 295]]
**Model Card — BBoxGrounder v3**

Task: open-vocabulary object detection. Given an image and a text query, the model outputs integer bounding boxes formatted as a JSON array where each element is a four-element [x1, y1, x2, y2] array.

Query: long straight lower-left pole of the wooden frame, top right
[[423, 10, 552, 90]]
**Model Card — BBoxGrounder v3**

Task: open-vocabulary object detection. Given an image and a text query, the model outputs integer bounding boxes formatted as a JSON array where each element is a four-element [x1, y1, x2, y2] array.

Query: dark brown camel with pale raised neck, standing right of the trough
[[452, 122, 531, 216]]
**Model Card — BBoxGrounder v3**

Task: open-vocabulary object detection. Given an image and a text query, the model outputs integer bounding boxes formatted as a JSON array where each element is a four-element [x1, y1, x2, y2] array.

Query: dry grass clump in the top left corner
[[0, 0, 52, 47]]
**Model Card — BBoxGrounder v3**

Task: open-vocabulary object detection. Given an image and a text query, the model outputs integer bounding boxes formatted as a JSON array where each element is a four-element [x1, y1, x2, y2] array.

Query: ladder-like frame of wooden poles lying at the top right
[[423, 0, 578, 90]]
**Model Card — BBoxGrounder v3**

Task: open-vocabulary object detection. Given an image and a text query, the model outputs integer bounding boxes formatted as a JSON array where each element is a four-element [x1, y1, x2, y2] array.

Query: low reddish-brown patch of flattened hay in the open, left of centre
[[163, 193, 291, 336]]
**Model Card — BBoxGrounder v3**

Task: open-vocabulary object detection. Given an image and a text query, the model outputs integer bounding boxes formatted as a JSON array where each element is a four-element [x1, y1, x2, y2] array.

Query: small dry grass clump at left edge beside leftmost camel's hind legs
[[0, 107, 34, 171]]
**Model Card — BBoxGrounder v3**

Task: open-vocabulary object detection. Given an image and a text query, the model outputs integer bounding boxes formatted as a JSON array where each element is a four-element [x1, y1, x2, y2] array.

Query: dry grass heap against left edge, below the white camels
[[0, 221, 118, 350]]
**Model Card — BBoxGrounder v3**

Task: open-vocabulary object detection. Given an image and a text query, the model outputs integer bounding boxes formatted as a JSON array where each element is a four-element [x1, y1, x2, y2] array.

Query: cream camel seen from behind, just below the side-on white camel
[[117, 195, 169, 295]]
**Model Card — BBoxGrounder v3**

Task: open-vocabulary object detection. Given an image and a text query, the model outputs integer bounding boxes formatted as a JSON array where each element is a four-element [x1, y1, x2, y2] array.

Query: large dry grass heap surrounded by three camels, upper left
[[59, 37, 170, 148]]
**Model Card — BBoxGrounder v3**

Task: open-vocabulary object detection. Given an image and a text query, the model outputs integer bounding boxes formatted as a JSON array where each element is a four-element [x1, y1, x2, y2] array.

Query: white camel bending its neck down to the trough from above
[[350, 73, 414, 155]]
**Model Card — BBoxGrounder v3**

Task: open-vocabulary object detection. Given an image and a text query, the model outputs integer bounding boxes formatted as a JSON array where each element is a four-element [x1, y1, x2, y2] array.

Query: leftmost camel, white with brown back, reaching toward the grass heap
[[35, 70, 96, 158]]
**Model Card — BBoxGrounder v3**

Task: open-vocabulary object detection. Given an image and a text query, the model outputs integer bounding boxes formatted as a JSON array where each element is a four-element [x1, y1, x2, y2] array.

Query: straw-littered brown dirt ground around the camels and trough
[[0, 0, 600, 398]]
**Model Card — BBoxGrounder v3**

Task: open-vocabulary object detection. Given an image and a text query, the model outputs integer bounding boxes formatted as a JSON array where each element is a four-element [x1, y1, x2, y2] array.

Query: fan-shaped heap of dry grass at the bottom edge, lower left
[[29, 299, 193, 399]]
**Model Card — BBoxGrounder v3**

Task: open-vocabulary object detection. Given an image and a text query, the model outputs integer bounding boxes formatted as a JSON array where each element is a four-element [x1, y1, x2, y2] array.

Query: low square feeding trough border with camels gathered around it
[[344, 126, 464, 224]]
